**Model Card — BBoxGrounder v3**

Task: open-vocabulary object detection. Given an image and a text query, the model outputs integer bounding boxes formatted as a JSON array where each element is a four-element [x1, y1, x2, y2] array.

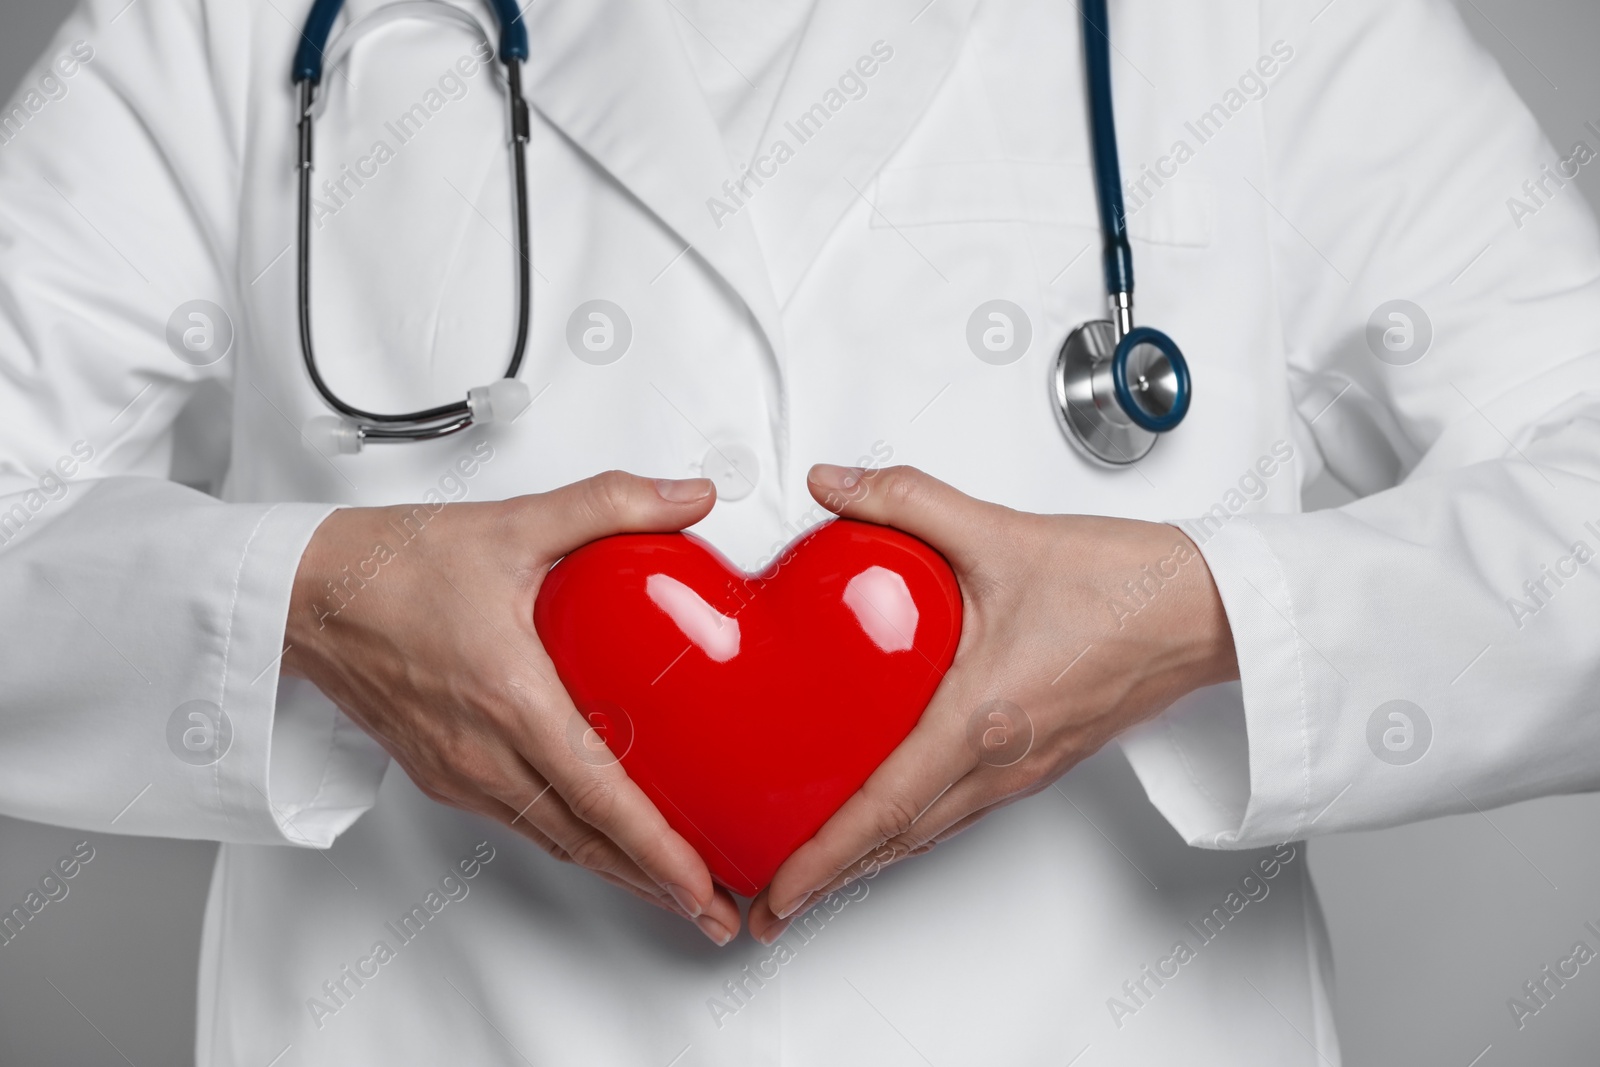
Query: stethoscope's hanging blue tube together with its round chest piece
[[1053, 0, 1192, 467]]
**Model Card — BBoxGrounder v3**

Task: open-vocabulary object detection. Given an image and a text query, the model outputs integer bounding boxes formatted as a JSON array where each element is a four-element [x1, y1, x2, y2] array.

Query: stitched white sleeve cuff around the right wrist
[[1122, 517, 1315, 848]]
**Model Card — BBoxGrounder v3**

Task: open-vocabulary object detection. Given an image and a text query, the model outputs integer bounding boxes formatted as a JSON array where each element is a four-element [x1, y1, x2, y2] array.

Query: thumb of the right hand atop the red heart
[[806, 464, 995, 561]]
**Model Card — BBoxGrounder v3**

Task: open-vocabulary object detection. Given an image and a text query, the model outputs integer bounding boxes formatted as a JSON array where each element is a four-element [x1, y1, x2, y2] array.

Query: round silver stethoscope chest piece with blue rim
[[1050, 318, 1189, 467]]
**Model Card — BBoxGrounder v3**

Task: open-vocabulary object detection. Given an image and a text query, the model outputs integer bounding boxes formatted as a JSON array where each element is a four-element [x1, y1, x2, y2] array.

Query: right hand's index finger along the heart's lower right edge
[[768, 672, 978, 918]]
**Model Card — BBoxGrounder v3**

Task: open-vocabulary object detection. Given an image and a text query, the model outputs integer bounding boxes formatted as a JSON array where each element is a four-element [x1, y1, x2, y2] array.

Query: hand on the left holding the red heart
[[283, 470, 739, 945]]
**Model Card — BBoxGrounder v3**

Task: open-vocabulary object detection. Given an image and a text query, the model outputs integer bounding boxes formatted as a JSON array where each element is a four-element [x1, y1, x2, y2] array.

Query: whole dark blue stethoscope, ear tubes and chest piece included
[[294, 0, 1190, 467]]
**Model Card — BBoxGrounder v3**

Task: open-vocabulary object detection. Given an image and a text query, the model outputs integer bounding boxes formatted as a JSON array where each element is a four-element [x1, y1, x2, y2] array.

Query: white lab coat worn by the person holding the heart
[[0, 0, 1600, 1067]]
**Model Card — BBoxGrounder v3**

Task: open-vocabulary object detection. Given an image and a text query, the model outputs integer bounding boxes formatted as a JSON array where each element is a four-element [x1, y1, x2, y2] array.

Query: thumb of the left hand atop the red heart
[[538, 470, 717, 555]]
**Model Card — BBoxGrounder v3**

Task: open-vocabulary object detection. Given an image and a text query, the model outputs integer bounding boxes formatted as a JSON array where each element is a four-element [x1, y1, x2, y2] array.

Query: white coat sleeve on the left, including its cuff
[[0, 0, 386, 846]]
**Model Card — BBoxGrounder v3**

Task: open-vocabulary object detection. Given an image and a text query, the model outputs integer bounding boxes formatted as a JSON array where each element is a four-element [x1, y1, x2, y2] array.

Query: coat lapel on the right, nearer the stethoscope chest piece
[[741, 0, 976, 302]]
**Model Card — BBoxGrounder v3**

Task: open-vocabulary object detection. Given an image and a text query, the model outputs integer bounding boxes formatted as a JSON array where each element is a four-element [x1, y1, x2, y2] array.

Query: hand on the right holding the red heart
[[749, 464, 1238, 944]]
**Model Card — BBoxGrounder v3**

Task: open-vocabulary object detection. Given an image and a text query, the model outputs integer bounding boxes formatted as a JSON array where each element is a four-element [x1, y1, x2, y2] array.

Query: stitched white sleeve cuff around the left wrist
[[216, 504, 389, 848]]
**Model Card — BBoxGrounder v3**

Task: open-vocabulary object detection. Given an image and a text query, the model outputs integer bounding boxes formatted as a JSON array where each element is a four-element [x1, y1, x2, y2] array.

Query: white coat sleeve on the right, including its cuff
[[1125, 0, 1600, 848]]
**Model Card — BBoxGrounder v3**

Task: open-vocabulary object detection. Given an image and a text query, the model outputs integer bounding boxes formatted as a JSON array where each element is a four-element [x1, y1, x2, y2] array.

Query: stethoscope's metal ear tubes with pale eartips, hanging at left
[[293, 0, 531, 453]]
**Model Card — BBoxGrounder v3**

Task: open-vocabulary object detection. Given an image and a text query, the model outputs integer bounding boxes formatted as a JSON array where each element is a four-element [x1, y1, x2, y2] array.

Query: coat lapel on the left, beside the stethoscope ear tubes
[[523, 0, 782, 358]]
